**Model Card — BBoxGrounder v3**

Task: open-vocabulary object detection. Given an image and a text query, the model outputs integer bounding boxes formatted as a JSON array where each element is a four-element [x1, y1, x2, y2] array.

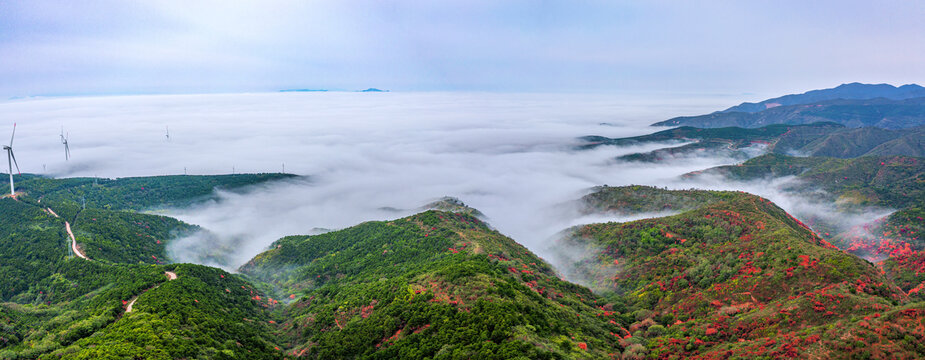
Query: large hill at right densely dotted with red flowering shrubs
[[559, 187, 925, 358]]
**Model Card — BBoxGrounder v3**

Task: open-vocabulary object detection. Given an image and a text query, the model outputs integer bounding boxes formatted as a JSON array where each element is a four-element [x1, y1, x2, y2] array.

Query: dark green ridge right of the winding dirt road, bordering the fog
[[3, 174, 298, 264]]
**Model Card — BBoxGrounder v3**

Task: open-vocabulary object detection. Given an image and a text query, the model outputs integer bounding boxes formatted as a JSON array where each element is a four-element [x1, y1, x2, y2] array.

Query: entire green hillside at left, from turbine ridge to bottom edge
[[0, 175, 298, 359]]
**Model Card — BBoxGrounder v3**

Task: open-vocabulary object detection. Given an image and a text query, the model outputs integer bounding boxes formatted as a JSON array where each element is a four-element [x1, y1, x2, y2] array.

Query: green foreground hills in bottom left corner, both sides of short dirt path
[[0, 259, 281, 359]]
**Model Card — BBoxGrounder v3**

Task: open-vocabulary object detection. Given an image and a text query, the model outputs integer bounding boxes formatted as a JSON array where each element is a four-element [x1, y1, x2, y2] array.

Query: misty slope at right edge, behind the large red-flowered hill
[[689, 154, 925, 306]]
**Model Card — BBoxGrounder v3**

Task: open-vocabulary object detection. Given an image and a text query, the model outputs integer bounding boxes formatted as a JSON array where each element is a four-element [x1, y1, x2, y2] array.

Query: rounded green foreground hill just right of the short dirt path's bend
[[61, 264, 282, 359]]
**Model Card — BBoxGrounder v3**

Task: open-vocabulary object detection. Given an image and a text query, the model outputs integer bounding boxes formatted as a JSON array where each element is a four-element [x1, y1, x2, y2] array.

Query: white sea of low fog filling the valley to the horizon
[[0, 93, 872, 269]]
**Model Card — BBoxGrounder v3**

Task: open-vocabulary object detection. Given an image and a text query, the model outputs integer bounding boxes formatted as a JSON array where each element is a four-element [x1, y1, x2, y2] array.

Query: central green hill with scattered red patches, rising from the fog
[[242, 211, 626, 359]]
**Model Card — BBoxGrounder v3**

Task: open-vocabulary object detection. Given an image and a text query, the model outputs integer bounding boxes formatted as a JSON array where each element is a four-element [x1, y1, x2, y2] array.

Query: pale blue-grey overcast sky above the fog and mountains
[[0, 0, 925, 100]]
